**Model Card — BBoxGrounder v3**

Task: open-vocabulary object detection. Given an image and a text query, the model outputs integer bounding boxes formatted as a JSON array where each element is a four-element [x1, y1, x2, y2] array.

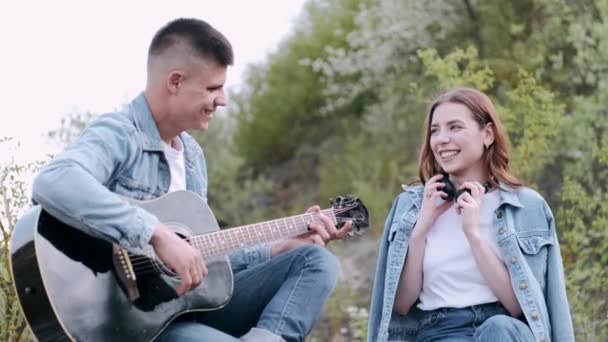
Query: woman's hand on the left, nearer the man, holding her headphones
[[414, 174, 452, 234]]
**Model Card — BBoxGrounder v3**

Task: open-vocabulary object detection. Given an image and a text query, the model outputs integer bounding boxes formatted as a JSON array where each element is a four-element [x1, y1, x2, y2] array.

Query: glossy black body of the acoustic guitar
[[10, 191, 233, 342]]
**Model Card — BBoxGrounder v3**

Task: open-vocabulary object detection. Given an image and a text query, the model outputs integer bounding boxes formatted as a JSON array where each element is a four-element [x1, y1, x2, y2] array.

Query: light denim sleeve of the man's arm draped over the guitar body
[[32, 113, 158, 249]]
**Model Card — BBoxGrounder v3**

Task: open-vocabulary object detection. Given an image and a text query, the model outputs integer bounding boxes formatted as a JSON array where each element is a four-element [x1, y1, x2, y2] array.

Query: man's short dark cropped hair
[[148, 18, 234, 65]]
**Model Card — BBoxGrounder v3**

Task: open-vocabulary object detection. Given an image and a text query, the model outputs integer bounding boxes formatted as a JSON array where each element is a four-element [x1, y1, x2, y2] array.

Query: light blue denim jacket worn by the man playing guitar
[[32, 93, 270, 271]]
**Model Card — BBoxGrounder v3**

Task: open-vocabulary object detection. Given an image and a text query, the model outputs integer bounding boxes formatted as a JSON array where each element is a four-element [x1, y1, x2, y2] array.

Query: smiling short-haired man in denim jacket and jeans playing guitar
[[33, 19, 350, 342]]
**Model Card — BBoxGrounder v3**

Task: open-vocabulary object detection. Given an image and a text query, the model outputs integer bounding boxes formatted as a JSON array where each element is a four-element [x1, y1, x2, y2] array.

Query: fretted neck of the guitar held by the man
[[189, 209, 336, 257]]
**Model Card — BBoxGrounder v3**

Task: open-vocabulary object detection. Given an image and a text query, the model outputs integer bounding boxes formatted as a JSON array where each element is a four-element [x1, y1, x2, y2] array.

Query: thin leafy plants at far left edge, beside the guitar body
[[0, 138, 40, 342]]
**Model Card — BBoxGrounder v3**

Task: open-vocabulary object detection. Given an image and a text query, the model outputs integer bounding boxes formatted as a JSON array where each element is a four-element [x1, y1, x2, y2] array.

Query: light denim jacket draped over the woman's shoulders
[[368, 184, 574, 342]]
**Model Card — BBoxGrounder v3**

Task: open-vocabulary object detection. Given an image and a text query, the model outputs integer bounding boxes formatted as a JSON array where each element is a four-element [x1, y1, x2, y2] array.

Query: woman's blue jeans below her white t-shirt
[[416, 302, 534, 342]]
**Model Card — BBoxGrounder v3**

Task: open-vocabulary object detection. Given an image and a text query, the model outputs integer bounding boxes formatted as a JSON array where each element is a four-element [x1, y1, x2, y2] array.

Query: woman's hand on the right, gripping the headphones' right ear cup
[[456, 182, 485, 237]]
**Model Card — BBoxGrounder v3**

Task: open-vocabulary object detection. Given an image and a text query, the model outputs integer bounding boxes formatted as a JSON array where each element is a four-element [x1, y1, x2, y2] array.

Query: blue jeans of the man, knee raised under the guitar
[[157, 245, 340, 342]]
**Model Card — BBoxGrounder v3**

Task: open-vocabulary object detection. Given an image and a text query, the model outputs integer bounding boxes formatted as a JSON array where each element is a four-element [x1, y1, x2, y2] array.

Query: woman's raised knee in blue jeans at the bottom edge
[[473, 315, 534, 341]]
